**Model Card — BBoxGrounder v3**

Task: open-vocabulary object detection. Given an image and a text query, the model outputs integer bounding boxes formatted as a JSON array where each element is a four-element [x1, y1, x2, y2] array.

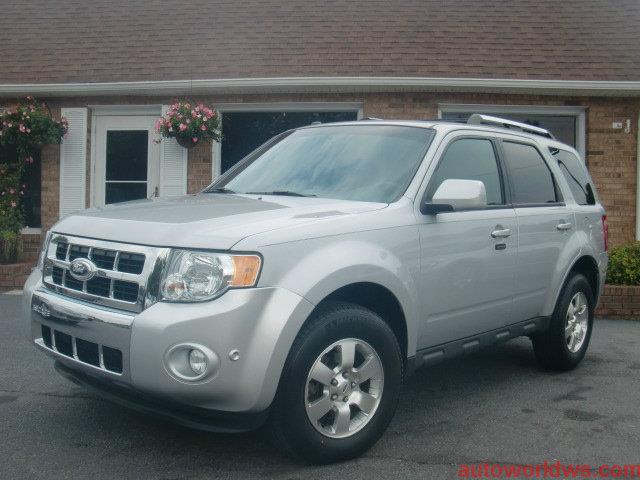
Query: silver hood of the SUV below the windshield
[[53, 193, 387, 250]]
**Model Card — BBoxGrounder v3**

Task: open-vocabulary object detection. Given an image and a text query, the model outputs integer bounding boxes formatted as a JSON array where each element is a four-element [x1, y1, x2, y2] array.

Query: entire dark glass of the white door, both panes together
[[105, 130, 149, 204]]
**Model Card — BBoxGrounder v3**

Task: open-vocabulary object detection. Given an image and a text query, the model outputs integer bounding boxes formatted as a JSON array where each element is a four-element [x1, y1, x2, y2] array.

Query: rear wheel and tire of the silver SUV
[[532, 274, 595, 371]]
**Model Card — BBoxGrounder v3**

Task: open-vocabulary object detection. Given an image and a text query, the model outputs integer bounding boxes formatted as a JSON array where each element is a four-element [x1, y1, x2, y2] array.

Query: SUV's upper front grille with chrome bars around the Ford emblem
[[43, 234, 161, 312]]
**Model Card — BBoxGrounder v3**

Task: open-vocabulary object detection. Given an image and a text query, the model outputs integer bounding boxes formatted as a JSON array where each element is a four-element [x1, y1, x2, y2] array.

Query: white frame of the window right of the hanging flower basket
[[211, 102, 364, 180]]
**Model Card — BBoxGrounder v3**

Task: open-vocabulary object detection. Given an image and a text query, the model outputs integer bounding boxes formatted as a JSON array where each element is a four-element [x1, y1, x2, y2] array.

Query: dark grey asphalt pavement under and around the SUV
[[0, 295, 640, 480]]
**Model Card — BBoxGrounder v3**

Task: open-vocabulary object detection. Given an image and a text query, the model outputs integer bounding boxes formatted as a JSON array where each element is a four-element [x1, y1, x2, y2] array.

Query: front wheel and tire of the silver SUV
[[270, 302, 404, 464]]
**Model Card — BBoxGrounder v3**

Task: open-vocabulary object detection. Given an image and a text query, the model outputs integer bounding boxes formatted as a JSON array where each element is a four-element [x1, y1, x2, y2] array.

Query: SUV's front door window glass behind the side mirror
[[429, 138, 504, 205]]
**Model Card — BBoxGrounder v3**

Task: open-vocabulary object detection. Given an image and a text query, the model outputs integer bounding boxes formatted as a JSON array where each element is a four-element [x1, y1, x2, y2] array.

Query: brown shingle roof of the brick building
[[0, 0, 640, 84]]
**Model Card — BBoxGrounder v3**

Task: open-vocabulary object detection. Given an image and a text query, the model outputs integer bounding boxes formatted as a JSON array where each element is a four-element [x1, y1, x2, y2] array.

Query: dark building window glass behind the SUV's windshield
[[221, 110, 358, 173]]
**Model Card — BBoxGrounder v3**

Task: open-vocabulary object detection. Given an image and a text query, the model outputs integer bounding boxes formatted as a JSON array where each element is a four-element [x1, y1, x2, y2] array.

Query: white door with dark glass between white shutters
[[93, 115, 160, 206]]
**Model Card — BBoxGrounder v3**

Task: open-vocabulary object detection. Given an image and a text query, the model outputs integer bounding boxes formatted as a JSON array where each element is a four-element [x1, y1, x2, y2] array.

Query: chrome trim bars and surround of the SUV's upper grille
[[42, 233, 169, 313]]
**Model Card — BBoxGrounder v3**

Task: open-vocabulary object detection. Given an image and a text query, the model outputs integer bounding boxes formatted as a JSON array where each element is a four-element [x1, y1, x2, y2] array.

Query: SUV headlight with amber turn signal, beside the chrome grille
[[160, 250, 262, 302]]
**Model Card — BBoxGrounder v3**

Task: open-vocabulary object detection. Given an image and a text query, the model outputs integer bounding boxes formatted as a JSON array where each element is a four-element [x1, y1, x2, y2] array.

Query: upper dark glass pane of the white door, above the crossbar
[[106, 130, 149, 182]]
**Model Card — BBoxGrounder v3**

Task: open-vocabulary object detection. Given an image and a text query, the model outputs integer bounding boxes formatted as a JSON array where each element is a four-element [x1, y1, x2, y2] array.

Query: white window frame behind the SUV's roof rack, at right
[[438, 103, 587, 161]]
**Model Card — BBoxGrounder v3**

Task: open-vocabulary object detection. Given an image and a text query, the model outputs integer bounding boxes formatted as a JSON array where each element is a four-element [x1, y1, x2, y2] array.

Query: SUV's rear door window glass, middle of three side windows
[[502, 142, 558, 205]]
